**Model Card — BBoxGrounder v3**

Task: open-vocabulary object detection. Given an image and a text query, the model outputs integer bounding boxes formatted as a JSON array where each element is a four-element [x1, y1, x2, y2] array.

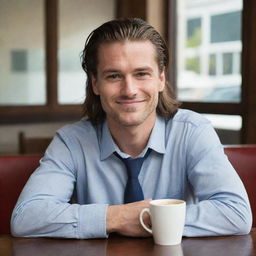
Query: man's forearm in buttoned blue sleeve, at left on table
[[11, 200, 107, 239]]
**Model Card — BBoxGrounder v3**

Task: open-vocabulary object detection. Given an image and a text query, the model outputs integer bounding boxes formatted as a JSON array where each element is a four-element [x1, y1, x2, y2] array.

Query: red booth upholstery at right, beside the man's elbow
[[224, 145, 256, 227]]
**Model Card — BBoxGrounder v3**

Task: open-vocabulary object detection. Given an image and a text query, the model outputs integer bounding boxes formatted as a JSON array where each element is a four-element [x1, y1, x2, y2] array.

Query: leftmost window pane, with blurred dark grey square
[[0, 0, 46, 105]]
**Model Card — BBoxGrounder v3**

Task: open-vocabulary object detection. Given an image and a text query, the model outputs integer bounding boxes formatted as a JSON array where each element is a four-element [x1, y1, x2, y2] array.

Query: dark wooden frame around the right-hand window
[[166, 0, 256, 144]]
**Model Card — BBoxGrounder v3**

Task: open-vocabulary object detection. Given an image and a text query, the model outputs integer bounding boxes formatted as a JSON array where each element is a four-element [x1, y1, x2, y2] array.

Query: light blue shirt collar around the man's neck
[[100, 116, 165, 160]]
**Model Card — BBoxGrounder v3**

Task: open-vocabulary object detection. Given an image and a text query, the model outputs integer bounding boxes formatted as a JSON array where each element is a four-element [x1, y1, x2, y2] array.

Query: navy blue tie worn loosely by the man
[[115, 150, 150, 203]]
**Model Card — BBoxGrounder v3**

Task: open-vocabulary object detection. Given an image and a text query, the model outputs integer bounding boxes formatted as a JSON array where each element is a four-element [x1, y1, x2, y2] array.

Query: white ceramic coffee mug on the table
[[140, 199, 186, 245]]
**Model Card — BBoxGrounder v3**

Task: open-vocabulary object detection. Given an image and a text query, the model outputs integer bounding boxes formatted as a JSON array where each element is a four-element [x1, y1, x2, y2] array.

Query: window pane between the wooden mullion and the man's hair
[[58, 0, 115, 104]]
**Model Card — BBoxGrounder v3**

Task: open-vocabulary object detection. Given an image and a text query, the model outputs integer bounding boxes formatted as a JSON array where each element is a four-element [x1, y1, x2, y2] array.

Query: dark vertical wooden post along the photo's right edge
[[242, 0, 256, 144]]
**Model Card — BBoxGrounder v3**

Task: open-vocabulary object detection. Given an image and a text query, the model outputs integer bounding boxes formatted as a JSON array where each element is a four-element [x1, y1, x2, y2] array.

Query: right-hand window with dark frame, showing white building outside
[[168, 0, 256, 143]]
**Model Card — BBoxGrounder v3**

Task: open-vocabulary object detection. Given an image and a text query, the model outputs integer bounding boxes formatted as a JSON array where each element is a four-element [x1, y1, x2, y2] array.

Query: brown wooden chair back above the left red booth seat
[[19, 132, 52, 154]]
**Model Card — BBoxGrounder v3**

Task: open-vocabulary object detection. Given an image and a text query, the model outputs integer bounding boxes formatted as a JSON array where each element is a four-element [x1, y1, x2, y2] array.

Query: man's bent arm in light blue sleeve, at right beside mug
[[184, 124, 252, 236]]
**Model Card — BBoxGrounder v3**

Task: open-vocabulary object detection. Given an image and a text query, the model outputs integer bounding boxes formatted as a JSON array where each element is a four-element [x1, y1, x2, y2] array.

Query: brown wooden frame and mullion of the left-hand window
[[0, 0, 83, 124]]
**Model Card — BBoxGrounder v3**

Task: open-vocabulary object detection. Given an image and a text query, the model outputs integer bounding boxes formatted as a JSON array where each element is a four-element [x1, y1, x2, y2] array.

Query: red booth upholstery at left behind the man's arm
[[0, 155, 42, 234]]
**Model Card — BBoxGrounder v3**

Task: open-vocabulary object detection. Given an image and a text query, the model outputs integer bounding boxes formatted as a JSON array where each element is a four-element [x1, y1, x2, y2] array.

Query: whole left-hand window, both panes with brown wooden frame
[[0, 0, 115, 123]]
